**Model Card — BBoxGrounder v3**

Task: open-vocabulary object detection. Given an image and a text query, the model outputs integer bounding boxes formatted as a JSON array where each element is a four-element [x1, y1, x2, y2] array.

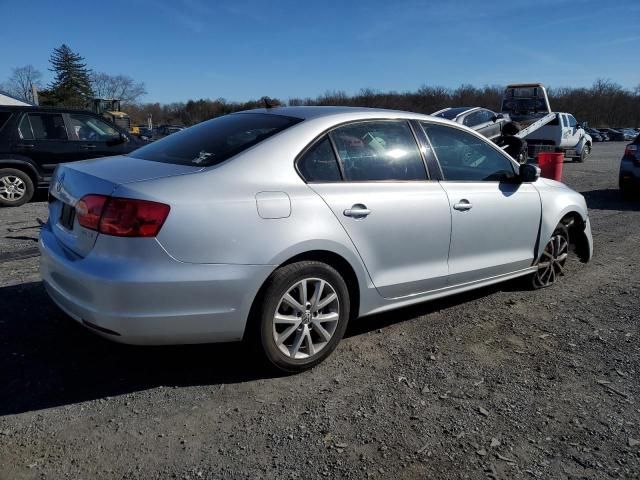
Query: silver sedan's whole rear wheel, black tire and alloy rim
[[253, 261, 350, 373]]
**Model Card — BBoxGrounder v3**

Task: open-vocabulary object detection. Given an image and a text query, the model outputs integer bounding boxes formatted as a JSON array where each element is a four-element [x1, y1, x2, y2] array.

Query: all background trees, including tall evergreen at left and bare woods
[[0, 44, 640, 127]]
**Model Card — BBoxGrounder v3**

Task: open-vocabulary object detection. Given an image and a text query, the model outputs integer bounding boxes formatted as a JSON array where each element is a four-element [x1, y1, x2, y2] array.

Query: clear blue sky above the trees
[[0, 0, 640, 103]]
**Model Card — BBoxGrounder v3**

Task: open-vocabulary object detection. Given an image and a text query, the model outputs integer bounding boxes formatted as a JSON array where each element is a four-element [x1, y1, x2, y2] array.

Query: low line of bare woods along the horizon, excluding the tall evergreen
[[127, 79, 640, 127]]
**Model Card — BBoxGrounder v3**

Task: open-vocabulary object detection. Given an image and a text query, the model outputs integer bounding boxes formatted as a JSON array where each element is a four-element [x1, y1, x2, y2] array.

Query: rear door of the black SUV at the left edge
[[16, 112, 75, 179]]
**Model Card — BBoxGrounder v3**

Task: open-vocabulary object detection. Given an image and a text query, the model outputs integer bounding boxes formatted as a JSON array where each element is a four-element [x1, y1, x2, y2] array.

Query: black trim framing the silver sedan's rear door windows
[[293, 117, 433, 184]]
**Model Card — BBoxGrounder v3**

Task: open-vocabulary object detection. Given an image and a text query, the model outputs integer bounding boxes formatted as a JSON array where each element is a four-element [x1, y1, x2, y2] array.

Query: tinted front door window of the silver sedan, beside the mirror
[[422, 123, 515, 182]]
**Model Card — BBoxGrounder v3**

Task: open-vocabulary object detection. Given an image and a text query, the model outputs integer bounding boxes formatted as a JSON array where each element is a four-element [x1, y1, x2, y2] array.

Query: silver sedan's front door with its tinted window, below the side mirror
[[422, 122, 541, 285]]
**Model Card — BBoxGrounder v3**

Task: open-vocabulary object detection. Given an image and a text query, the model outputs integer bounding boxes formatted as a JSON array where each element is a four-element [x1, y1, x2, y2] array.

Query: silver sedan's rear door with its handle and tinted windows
[[297, 120, 451, 298]]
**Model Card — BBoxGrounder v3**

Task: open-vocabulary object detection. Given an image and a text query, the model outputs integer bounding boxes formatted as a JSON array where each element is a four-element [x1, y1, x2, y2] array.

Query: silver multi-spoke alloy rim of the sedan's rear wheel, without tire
[[273, 278, 340, 359]]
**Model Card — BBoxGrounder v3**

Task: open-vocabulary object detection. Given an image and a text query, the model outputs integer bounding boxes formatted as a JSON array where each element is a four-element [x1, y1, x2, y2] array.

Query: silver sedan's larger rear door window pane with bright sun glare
[[330, 121, 427, 182]]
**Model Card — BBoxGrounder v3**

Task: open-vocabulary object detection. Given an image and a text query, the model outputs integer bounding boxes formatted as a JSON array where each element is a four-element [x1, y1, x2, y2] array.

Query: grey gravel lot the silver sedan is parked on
[[0, 142, 640, 479]]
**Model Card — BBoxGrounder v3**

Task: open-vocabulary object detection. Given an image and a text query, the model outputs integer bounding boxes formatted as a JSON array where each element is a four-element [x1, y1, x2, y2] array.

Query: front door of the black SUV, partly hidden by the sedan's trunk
[[65, 113, 130, 160]]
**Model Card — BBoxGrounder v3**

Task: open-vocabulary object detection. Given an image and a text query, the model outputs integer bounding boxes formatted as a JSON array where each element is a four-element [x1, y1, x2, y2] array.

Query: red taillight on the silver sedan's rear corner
[[76, 195, 170, 237]]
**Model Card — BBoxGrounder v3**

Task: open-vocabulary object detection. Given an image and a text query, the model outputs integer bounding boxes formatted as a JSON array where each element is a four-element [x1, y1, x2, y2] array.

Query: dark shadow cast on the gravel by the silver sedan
[[0, 282, 517, 416]]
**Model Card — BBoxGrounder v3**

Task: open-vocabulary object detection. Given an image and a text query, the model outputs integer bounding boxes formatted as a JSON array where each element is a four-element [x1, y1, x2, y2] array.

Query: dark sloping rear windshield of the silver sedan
[[129, 113, 302, 167]]
